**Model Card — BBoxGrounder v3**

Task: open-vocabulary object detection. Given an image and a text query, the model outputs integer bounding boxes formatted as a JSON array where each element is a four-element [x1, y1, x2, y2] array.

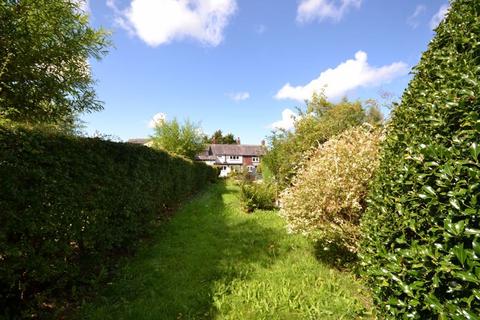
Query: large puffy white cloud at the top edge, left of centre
[[107, 0, 237, 47]]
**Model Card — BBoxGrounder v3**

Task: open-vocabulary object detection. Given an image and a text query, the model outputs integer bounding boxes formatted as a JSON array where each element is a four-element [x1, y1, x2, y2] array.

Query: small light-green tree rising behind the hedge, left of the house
[[151, 119, 205, 160]]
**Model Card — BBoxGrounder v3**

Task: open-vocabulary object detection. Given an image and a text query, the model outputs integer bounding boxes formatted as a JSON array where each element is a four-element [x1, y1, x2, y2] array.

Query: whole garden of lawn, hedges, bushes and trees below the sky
[[0, 0, 480, 319]]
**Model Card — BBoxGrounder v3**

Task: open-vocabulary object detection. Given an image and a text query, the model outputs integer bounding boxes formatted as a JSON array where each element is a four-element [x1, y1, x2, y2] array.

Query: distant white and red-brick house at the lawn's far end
[[196, 141, 267, 177]]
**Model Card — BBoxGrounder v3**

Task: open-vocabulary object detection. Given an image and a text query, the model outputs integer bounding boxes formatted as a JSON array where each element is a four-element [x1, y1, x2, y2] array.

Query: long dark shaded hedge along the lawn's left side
[[0, 126, 217, 318]]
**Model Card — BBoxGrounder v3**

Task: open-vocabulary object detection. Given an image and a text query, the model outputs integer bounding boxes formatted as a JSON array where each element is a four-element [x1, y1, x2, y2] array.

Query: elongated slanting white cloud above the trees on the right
[[275, 51, 408, 101]]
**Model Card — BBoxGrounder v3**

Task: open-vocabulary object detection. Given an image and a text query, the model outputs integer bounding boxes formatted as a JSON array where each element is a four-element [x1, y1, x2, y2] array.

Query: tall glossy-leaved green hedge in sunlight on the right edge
[[362, 0, 480, 319]]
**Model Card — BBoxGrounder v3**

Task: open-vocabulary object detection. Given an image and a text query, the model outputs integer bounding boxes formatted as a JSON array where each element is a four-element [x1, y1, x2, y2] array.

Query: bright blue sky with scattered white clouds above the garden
[[83, 0, 448, 144]]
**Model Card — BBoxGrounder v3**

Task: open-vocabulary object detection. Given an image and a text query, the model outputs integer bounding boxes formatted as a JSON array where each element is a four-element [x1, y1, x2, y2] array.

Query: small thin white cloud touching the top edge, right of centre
[[297, 0, 362, 23]]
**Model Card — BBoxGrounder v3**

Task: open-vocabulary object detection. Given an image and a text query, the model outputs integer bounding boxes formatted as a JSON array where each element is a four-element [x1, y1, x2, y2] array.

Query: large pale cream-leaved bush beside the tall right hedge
[[280, 126, 380, 252]]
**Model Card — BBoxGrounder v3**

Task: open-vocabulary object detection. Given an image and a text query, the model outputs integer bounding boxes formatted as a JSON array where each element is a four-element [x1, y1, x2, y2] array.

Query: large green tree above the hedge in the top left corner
[[0, 0, 110, 128]]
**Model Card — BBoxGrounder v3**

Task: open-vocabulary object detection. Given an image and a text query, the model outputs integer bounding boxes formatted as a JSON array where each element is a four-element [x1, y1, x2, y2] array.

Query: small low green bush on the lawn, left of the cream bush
[[240, 182, 277, 212]]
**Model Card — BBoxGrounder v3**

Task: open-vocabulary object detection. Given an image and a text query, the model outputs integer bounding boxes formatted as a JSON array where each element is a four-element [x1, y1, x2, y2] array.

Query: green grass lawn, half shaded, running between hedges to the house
[[78, 184, 368, 320]]
